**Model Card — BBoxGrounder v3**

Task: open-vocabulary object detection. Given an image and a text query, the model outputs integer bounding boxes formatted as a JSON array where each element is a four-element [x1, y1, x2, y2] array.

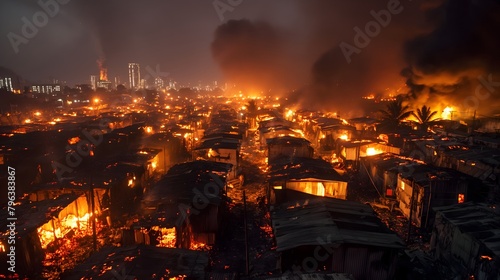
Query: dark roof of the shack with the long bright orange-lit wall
[[268, 156, 346, 182]]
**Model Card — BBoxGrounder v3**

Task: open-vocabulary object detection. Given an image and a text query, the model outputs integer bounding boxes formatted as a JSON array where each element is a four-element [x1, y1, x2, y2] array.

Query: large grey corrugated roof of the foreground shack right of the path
[[271, 198, 404, 252]]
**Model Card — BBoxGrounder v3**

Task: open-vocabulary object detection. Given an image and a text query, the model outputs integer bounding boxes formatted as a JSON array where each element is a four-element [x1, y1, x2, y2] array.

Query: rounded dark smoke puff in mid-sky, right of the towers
[[212, 20, 289, 93]]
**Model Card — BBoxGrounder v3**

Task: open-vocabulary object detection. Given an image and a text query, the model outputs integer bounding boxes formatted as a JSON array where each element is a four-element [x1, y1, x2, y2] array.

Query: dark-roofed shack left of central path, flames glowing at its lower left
[[140, 160, 231, 248]]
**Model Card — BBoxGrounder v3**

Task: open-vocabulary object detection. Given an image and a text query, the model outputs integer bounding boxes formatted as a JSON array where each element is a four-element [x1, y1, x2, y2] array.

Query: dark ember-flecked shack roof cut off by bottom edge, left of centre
[[63, 245, 208, 280]]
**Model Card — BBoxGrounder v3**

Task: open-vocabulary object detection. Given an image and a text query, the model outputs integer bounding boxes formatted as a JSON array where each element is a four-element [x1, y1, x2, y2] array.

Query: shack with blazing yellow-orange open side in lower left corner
[[0, 194, 100, 275]]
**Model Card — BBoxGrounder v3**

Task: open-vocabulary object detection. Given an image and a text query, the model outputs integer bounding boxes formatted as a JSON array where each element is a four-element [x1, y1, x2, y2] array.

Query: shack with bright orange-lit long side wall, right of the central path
[[267, 156, 347, 204]]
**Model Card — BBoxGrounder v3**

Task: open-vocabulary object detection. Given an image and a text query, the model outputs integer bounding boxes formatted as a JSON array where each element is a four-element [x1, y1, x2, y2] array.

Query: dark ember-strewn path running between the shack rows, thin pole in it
[[210, 151, 276, 277]]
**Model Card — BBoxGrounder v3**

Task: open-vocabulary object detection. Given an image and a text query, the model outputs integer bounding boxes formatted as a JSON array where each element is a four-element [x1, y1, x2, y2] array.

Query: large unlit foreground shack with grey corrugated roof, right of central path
[[271, 198, 404, 279]]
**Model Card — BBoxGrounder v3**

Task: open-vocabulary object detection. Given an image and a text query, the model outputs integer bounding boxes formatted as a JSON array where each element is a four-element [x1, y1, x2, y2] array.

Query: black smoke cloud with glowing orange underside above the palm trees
[[402, 0, 500, 117]]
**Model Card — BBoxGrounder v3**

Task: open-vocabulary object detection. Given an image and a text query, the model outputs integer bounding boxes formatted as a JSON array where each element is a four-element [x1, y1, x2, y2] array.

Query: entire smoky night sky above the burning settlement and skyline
[[0, 0, 500, 114]]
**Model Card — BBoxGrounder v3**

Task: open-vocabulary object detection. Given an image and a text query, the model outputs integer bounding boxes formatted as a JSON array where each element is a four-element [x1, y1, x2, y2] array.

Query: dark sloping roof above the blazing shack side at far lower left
[[0, 194, 79, 238]]
